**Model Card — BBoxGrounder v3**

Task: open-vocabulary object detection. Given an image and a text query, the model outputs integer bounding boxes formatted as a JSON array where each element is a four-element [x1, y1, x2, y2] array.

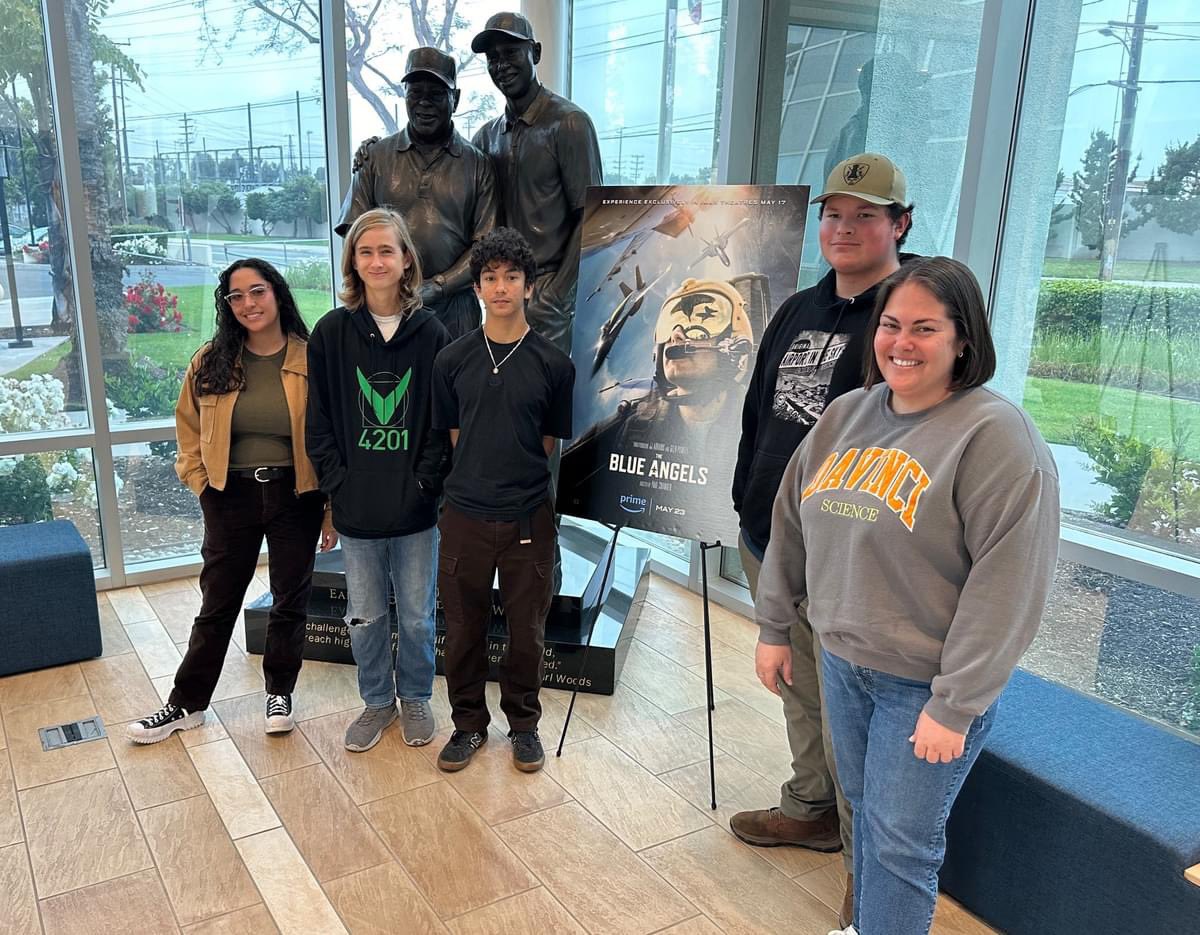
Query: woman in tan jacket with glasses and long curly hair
[[127, 258, 337, 743]]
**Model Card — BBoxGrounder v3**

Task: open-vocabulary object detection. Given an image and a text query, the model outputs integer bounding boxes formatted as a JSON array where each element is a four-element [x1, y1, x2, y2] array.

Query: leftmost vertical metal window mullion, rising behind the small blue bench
[[42, 0, 125, 587]]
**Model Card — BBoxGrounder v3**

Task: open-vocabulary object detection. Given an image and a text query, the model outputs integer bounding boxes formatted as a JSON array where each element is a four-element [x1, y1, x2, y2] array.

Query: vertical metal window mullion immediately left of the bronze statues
[[319, 0, 353, 282]]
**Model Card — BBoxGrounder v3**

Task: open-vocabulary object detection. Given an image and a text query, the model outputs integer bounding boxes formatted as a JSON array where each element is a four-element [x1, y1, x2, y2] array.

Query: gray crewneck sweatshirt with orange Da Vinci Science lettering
[[755, 383, 1058, 732]]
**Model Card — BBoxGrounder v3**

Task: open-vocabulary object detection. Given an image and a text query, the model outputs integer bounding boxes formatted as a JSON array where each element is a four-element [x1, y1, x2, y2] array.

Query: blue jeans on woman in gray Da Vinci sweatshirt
[[822, 652, 996, 935]]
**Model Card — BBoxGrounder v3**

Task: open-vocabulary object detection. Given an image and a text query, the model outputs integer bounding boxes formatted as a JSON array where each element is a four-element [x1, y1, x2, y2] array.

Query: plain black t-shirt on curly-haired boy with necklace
[[433, 329, 575, 520]]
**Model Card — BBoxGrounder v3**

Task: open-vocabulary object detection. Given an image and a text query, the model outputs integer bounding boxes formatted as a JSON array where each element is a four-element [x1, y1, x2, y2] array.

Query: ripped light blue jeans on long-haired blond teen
[[341, 526, 438, 708]]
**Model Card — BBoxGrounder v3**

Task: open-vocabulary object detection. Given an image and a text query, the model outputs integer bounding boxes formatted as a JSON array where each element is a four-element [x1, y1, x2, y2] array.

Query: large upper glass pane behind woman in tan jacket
[[72, 0, 332, 428]]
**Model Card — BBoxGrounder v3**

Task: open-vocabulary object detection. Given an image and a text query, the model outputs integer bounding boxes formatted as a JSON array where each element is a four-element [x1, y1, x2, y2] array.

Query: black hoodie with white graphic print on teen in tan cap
[[733, 253, 916, 555]]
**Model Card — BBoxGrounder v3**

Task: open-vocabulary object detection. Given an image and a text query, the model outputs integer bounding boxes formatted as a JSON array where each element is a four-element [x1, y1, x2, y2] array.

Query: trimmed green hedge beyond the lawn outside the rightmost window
[[1037, 280, 1200, 337]]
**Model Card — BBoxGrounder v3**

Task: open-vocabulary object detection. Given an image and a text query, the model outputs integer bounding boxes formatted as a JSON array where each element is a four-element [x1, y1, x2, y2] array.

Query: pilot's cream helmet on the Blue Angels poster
[[654, 278, 754, 390]]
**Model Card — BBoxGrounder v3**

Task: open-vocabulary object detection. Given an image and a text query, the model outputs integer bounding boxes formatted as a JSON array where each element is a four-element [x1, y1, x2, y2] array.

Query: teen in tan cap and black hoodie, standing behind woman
[[730, 152, 912, 928]]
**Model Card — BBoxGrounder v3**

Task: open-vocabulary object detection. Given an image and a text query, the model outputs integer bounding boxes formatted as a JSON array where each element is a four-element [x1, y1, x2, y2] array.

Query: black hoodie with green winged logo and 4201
[[305, 307, 450, 539]]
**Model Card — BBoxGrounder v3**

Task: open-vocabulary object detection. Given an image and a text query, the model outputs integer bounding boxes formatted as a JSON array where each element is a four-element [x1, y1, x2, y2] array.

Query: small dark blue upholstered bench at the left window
[[0, 520, 103, 676]]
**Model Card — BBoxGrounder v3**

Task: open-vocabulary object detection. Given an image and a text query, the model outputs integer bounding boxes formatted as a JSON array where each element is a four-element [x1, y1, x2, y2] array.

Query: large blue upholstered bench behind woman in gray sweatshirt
[[942, 671, 1200, 935]]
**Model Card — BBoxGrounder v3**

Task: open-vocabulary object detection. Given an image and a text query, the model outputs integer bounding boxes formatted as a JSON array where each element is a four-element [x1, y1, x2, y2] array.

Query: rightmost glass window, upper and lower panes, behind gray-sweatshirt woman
[[994, 0, 1200, 730]]
